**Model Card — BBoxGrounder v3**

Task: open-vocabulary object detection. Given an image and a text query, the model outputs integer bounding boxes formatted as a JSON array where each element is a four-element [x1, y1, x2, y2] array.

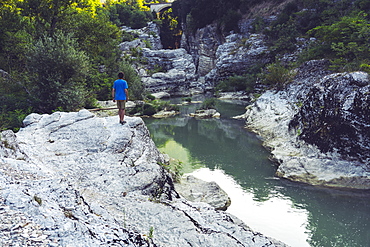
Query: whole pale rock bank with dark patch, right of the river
[[244, 60, 370, 189]]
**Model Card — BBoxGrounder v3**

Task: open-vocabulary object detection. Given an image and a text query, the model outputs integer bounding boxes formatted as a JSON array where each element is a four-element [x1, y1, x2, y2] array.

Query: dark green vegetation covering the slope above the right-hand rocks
[[173, 0, 370, 92]]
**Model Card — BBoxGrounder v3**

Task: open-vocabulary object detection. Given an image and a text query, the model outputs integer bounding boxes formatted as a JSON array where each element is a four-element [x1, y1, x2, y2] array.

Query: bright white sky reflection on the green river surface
[[192, 168, 309, 247]]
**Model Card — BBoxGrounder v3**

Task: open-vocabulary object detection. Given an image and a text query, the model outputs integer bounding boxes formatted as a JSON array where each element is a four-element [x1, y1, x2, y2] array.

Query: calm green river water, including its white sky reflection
[[144, 98, 370, 247]]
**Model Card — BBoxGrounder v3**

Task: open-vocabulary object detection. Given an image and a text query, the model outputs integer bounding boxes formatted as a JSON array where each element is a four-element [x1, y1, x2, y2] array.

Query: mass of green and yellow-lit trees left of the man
[[0, 0, 152, 130]]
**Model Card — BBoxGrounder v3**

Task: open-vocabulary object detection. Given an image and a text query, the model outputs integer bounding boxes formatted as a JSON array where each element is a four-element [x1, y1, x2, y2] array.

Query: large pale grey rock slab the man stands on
[[0, 110, 284, 247]]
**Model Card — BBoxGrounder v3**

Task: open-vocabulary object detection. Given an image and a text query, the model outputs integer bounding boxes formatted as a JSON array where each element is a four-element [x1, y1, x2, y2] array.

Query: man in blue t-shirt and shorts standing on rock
[[112, 72, 128, 124]]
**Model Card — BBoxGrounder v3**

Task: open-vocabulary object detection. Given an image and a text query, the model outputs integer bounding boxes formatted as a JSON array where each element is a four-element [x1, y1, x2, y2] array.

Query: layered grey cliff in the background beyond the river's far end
[[120, 21, 270, 96]]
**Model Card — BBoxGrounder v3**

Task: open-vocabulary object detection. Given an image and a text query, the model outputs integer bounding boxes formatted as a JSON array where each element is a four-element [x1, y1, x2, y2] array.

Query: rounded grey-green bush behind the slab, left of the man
[[28, 32, 90, 113]]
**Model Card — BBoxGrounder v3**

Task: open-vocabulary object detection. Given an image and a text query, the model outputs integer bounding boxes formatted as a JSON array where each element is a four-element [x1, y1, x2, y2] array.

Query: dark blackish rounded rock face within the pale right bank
[[290, 72, 370, 163]]
